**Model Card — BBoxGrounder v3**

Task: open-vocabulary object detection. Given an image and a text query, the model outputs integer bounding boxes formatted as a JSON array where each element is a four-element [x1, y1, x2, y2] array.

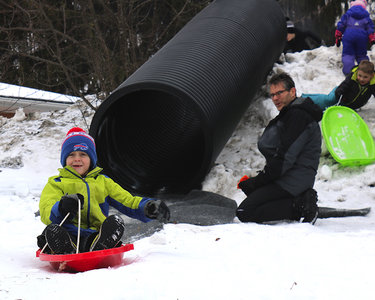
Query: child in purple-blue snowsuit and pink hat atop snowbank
[[335, 0, 375, 75]]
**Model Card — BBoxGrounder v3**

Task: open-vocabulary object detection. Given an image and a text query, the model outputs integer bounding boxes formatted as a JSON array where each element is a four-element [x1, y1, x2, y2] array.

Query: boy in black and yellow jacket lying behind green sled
[[302, 60, 375, 110]]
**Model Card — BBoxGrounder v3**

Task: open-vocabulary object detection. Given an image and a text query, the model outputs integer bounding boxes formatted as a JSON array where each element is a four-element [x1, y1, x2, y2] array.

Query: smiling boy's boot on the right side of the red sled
[[90, 215, 125, 251]]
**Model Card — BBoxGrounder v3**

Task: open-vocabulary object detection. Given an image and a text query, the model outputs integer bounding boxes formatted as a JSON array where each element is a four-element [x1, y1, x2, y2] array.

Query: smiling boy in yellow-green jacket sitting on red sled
[[37, 127, 170, 254]]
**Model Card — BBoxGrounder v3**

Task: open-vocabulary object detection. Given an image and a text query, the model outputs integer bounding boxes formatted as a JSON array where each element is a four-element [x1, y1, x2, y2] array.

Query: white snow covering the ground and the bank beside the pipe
[[0, 47, 375, 300]]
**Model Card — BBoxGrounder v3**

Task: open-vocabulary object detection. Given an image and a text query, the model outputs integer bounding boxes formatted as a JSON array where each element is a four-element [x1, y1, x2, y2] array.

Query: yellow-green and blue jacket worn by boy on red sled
[[39, 166, 151, 236]]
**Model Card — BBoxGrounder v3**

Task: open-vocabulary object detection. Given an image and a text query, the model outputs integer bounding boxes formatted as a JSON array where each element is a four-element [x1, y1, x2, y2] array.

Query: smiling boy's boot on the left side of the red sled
[[45, 224, 77, 254]]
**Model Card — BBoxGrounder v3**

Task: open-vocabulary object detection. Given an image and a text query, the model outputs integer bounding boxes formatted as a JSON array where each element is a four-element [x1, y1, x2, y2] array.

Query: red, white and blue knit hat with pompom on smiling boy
[[60, 127, 98, 168]]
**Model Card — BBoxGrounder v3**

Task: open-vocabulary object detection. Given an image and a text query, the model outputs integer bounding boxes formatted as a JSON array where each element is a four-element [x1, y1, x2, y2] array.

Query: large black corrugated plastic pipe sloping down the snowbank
[[90, 0, 286, 195]]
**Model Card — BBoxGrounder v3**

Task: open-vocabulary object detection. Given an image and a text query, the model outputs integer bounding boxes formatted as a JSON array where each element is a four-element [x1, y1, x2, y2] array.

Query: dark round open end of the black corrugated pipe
[[96, 90, 206, 195]]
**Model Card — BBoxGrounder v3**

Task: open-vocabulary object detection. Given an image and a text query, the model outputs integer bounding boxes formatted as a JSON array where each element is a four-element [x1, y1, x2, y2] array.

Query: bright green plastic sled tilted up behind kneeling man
[[322, 106, 375, 166]]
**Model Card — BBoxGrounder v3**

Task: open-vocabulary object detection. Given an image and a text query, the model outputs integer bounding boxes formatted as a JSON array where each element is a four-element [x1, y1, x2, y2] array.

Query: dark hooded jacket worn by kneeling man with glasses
[[239, 98, 323, 196]]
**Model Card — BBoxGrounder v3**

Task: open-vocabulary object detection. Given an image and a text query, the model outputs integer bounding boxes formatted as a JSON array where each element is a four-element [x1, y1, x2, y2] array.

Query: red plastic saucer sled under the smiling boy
[[36, 244, 134, 273]]
